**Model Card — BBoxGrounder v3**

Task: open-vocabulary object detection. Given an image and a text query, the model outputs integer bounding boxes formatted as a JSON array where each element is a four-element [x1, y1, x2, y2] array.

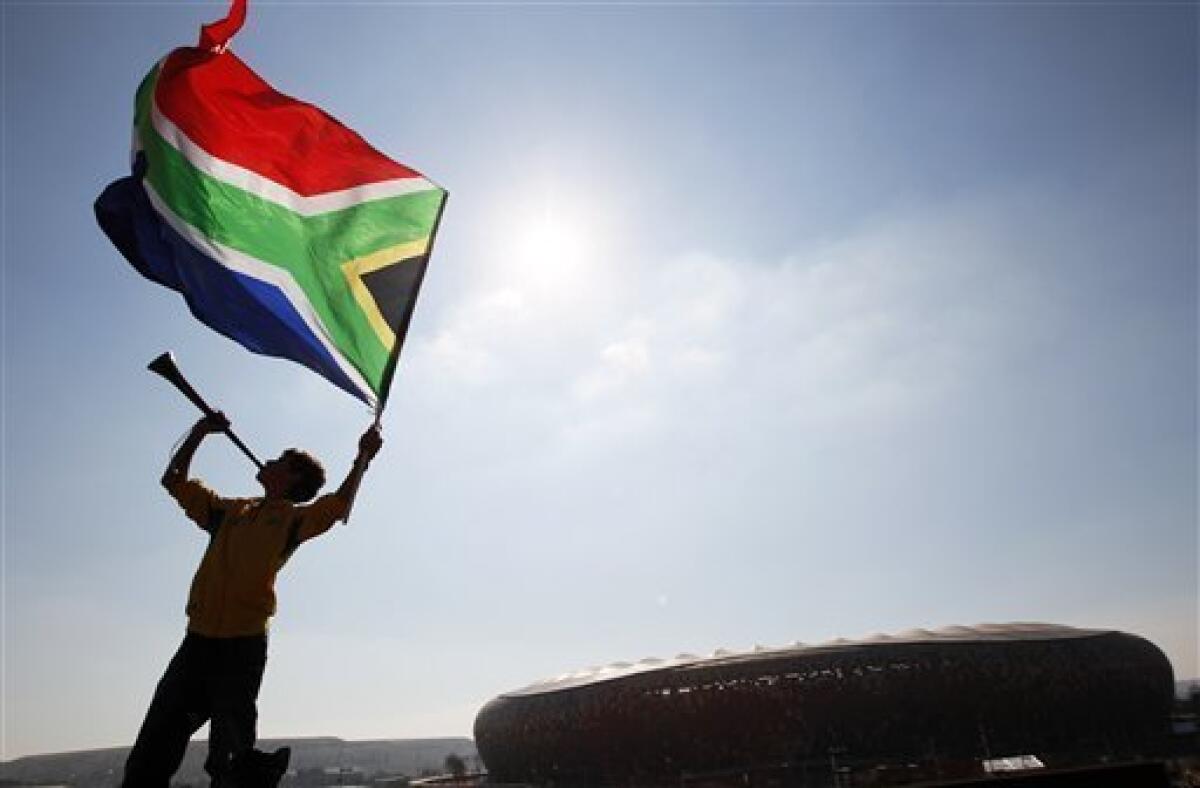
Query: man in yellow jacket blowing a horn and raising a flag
[[122, 413, 383, 788]]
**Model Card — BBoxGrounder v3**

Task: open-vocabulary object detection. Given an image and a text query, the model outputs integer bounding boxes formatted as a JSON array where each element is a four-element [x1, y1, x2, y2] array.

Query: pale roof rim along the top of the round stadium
[[500, 621, 1116, 698]]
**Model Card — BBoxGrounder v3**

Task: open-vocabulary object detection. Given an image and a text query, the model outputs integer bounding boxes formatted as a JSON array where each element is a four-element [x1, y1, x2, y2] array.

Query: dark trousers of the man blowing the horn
[[121, 632, 266, 788]]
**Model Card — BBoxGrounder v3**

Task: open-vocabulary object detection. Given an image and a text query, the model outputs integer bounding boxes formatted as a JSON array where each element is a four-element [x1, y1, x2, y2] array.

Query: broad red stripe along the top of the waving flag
[[155, 47, 421, 197]]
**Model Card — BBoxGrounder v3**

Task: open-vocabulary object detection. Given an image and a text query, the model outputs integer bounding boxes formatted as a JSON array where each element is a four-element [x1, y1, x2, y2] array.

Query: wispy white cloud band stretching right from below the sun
[[409, 191, 1032, 460]]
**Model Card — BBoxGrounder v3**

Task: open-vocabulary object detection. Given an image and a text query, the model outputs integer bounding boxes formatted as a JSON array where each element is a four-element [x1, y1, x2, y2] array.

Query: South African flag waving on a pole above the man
[[96, 23, 446, 407]]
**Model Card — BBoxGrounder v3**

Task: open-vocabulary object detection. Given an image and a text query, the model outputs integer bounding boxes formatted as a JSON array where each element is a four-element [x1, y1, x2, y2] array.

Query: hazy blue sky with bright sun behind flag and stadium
[[0, 0, 1200, 759]]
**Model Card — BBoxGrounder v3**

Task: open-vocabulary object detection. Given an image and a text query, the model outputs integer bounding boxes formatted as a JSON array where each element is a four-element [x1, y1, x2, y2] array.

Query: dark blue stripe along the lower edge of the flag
[[96, 176, 370, 402]]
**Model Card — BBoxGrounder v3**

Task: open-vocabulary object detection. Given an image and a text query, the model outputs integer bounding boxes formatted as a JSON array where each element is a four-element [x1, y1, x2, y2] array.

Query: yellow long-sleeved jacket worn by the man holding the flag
[[167, 479, 347, 638]]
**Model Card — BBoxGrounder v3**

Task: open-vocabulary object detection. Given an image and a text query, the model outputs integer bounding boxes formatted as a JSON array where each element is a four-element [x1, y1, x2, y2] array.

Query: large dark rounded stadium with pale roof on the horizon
[[475, 624, 1174, 784]]
